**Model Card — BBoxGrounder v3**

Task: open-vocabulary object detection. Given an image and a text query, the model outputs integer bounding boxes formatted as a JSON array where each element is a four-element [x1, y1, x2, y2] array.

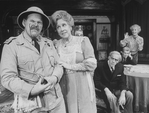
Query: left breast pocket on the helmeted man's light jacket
[[18, 55, 34, 72]]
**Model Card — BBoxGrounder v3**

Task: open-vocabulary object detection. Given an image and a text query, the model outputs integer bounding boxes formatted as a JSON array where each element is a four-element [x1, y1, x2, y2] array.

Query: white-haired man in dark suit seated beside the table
[[94, 51, 133, 113]]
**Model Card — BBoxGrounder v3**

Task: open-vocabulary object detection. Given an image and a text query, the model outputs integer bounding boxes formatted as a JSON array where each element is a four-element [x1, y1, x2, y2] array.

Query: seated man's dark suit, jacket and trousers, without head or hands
[[94, 61, 133, 113]]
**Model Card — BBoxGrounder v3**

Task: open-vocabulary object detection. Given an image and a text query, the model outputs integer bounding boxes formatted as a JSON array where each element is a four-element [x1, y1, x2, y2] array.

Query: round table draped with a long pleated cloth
[[124, 64, 149, 113]]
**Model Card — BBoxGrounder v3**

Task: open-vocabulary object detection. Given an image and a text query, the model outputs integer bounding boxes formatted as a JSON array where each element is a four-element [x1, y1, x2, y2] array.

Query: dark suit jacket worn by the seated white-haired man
[[94, 61, 126, 91]]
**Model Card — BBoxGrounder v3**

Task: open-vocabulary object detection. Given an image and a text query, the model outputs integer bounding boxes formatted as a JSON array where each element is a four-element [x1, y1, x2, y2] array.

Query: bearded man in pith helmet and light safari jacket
[[0, 7, 65, 113]]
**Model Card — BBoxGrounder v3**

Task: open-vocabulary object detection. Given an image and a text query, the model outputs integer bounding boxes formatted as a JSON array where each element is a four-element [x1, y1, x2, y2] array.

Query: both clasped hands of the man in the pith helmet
[[31, 75, 57, 95]]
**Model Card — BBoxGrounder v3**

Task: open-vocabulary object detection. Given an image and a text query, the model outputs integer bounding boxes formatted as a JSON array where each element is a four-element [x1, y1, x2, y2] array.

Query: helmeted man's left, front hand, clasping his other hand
[[31, 78, 51, 95]]
